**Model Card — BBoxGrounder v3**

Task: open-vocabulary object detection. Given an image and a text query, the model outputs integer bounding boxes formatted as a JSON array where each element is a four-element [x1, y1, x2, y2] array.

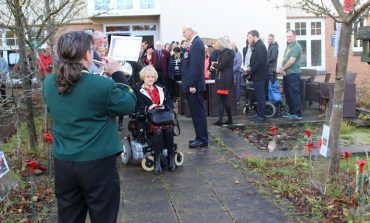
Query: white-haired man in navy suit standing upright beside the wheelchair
[[181, 24, 208, 148]]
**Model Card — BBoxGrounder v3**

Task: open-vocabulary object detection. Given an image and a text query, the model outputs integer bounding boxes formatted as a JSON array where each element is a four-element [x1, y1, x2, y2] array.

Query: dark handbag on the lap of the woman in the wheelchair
[[147, 108, 176, 125]]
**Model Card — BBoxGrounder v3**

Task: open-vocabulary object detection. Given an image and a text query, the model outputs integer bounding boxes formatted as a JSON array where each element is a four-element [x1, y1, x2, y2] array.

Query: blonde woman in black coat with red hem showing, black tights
[[211, 38, 235, 126]]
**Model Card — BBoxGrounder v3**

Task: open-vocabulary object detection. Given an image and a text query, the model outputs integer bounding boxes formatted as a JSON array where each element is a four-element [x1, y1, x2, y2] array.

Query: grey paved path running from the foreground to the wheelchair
[[119, 117, 292, 223]]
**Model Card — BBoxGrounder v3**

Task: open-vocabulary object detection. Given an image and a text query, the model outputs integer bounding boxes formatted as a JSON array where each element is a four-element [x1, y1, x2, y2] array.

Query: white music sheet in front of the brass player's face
[[108, 36, 143, 61]]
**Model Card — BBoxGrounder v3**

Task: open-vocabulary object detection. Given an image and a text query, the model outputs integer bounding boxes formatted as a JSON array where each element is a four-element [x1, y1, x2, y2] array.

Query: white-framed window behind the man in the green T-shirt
[[287, 19, 325, 70]]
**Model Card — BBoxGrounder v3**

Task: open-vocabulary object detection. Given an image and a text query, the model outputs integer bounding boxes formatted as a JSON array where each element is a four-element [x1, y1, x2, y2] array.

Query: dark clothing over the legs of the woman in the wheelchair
[[150, 127, 173, 156]]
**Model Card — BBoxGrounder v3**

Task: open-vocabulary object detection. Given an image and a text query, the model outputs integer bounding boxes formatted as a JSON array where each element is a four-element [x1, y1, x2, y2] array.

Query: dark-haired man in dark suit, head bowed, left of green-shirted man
[[247, 30, 269, 122]]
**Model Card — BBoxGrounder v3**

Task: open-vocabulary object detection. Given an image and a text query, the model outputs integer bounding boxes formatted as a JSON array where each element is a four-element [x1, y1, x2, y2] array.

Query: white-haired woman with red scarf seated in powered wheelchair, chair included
[[125, 66, 183, 175]]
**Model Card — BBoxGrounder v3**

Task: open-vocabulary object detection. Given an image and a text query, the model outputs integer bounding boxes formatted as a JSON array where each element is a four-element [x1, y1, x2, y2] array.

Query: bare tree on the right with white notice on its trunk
[[295, 0, 370, 175]]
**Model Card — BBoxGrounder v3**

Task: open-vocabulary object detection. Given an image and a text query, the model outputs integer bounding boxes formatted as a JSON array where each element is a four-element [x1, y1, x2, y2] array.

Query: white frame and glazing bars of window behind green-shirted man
[[287, 18, 326, 70]]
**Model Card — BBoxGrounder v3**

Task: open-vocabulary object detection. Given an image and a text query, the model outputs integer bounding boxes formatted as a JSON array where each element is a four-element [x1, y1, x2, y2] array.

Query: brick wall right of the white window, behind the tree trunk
[[325, 18, 370, 84]]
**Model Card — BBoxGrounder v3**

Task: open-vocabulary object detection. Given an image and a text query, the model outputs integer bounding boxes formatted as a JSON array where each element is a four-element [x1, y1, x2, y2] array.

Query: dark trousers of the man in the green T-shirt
[[283, 73, 302, 115]]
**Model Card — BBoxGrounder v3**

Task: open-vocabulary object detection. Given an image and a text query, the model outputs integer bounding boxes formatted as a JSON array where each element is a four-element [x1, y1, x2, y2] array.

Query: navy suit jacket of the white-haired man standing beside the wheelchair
[[181, 36, 206, 93]]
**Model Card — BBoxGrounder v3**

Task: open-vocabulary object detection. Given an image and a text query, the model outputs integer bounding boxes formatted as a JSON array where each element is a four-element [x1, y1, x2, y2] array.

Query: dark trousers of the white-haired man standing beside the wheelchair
[[186, 92, 208, 144]]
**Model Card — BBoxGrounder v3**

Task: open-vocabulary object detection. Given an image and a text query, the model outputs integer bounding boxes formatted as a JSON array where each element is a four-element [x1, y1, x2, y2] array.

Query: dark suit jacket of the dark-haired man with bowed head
[[249, 40, 269, 81]]
